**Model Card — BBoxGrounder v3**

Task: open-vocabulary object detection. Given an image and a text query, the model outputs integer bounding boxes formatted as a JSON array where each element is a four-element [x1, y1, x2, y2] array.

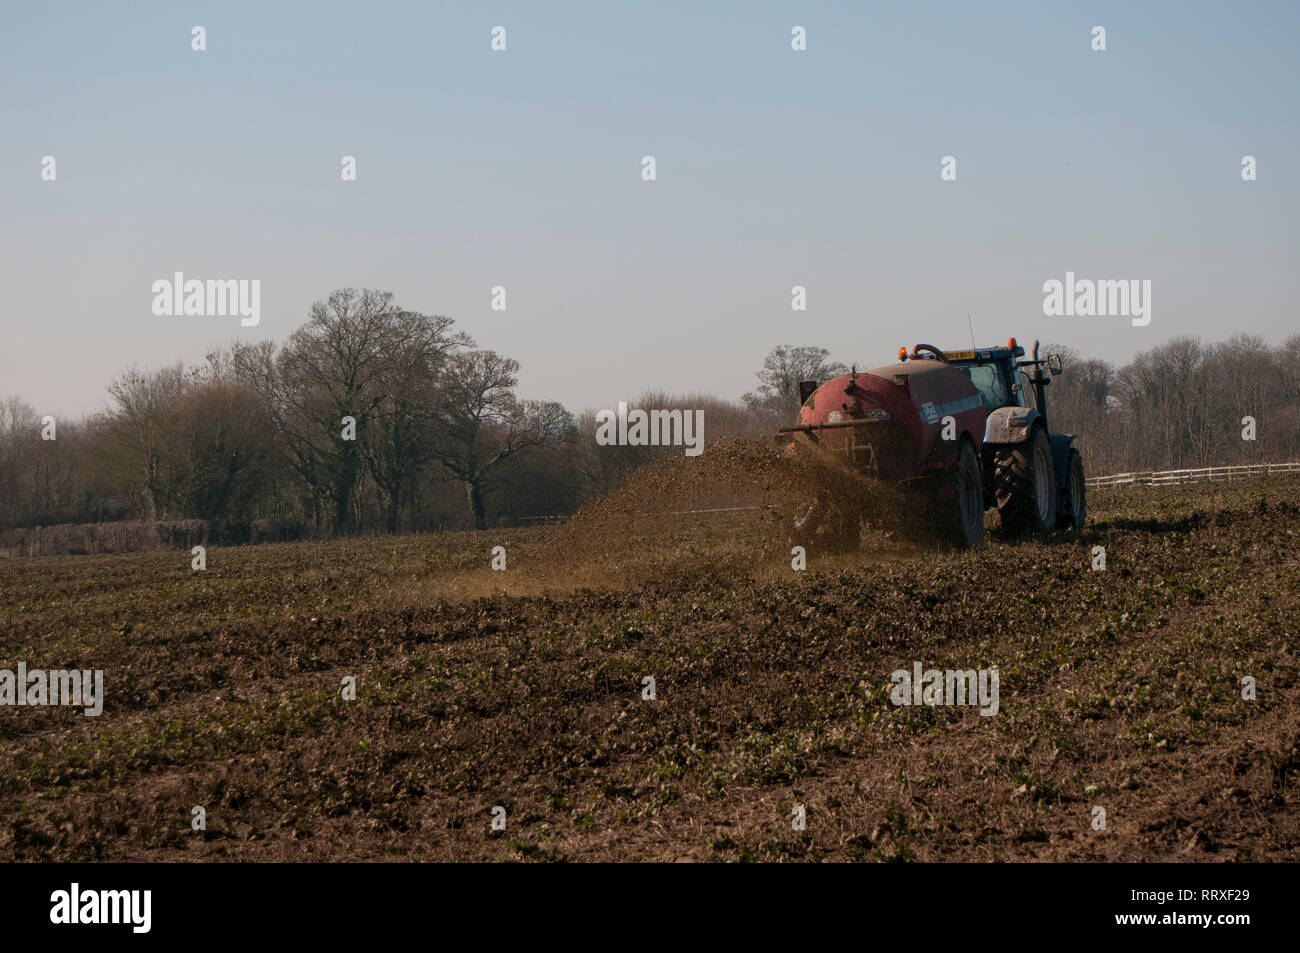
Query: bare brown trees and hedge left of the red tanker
[[0, 289, 771, 542]]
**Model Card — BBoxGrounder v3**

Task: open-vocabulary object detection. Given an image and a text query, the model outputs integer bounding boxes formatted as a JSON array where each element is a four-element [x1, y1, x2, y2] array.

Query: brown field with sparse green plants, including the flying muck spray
[[0, 451, 1300, 862]]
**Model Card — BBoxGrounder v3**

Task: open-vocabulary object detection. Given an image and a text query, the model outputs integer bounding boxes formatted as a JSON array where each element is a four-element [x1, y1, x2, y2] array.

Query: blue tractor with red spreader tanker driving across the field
[[777, 338, 1087, 547]]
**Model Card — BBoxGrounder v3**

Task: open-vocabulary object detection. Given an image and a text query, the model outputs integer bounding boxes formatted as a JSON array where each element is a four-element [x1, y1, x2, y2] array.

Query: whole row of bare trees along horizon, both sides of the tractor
[[0, 304, 1300, 542]]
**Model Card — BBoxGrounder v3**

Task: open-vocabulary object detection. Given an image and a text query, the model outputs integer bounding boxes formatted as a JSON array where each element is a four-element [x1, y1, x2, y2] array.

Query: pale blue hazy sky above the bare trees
[[0, 0, 1300, 415]]
